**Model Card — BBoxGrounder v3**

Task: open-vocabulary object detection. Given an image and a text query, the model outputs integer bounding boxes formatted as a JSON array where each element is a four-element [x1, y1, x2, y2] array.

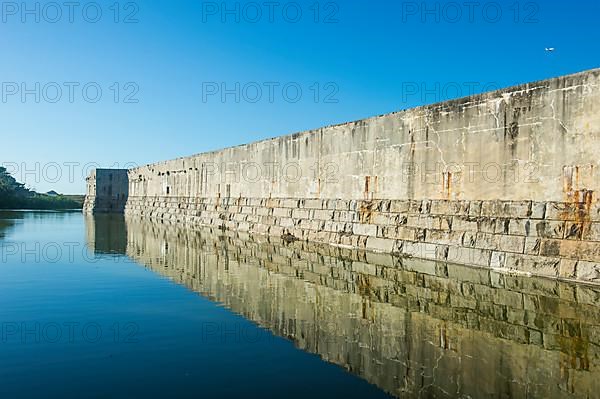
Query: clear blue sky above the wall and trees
[[0, 0, 600, 193]]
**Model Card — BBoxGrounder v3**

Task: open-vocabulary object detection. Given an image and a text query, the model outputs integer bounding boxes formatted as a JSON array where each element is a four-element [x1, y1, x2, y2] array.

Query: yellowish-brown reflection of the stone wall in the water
[[87, 216, 600, 398]]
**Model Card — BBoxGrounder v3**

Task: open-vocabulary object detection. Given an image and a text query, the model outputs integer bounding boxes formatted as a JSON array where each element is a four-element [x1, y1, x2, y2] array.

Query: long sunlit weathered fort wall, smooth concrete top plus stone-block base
[[85, 70, 600, 282]]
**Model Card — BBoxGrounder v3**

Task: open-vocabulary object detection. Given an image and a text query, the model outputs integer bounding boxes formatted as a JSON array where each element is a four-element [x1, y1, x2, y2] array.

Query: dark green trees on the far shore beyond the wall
[[0, 166, 83, 210]]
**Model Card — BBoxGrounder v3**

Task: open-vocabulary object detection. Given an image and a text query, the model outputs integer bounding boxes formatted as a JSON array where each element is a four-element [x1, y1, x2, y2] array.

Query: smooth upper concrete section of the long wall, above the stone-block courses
[[130, 70, 600, 201]]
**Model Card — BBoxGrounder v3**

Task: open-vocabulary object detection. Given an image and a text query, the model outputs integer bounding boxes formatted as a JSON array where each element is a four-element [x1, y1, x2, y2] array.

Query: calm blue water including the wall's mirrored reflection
[[0, 212, 600, 398]]
